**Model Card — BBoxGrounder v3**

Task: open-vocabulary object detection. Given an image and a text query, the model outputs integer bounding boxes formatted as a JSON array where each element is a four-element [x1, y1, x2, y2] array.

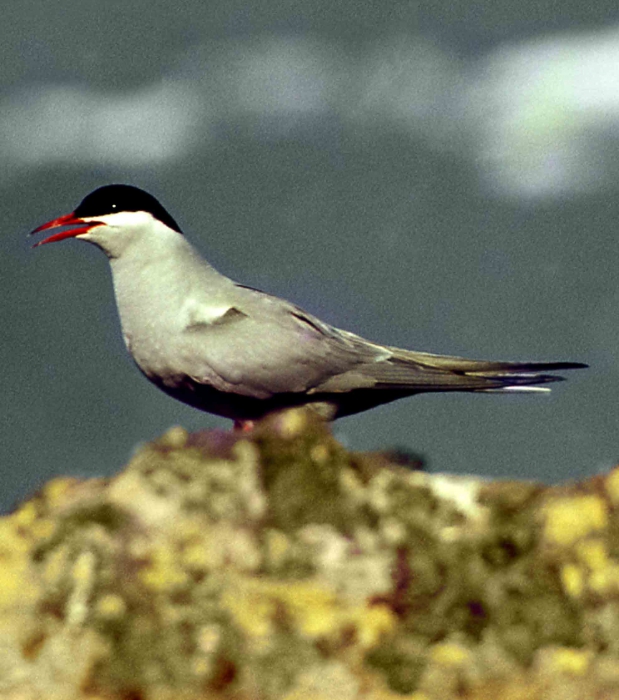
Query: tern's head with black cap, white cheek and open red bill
[[32, 185, 182, 258]]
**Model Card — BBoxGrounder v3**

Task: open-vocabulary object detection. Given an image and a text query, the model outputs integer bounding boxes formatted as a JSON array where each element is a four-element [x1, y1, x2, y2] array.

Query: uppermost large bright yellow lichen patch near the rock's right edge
[[544, 496, 608, 546]]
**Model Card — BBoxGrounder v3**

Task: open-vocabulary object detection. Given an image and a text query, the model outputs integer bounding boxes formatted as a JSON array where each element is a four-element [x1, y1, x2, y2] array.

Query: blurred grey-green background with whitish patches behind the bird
[[0, 0, 619, 508]]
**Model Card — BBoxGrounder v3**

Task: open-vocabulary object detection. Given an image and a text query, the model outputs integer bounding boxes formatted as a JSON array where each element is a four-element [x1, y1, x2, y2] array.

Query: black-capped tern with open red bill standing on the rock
[[31, 184, 587, 430]]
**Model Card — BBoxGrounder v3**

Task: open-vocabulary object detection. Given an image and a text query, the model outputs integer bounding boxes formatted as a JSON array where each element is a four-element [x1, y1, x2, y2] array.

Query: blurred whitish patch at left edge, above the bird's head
[[0, 81, 207, 167]]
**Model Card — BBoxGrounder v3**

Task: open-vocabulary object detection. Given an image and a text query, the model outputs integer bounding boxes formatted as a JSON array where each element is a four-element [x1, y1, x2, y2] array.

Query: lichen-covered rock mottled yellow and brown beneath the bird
[[0, 410, 619, 700]]
